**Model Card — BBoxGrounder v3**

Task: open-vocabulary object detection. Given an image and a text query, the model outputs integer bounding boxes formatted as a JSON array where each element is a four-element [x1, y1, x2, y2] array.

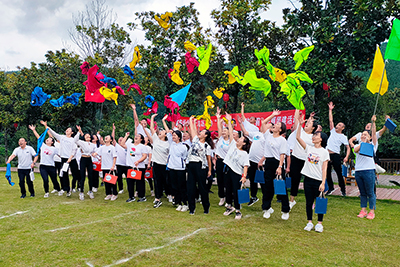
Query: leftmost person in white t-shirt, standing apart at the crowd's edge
[[6, 138, 38, 198]]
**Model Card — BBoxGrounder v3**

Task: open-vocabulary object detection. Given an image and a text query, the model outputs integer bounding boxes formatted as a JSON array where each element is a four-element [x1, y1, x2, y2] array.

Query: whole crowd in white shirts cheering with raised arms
[[7, 102, 386, 232]]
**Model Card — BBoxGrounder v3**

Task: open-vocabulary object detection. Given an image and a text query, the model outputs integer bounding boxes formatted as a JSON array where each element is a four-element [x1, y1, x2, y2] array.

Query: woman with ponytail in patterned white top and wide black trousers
[[187, 117, 214, 215]]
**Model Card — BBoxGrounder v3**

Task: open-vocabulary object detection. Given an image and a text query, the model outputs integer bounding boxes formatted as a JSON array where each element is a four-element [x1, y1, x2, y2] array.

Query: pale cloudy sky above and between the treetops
[[0, 0, 297, 71]]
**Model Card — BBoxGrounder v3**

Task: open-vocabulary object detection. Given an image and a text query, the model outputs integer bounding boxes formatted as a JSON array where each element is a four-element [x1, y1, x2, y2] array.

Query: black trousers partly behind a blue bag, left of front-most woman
[[261, 158, 290, 212]]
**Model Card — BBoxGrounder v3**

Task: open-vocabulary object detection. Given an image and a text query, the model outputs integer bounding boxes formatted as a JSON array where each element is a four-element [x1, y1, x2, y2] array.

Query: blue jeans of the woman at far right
[[355, 170, 376, 209]]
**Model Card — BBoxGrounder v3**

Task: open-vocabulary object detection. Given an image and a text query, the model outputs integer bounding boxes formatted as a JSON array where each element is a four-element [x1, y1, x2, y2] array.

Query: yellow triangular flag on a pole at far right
[[367, 45, 389, 95]]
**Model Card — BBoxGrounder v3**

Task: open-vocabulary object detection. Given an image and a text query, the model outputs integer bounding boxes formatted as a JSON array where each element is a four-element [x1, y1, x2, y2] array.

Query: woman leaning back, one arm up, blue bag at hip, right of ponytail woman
[[224, 114, 251, 220]]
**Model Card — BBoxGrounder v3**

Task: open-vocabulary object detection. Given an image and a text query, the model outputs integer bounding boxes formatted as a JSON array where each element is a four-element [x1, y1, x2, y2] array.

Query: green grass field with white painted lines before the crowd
[[0, 172, 400, 266]]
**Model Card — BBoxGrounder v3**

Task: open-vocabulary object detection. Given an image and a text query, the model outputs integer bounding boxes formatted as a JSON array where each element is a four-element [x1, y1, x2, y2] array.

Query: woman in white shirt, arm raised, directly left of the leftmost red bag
[[74, 125, 96, 200]]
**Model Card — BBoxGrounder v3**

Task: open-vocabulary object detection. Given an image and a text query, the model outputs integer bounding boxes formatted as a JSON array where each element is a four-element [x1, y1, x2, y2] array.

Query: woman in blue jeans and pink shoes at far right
[[354, 115, 377, 220]]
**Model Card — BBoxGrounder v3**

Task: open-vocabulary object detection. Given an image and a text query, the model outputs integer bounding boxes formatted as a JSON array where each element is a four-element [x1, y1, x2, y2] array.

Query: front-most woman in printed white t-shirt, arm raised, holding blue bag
[[296, 115, 329, 233]]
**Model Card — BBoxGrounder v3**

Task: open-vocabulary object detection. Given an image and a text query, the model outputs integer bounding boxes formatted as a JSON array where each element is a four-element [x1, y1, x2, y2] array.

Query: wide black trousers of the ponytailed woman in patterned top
[[187, 162, 210, 212]]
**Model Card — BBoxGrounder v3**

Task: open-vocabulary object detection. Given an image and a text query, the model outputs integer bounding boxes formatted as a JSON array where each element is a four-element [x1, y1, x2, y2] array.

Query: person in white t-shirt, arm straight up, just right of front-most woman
[[326, 102, 350, 196]]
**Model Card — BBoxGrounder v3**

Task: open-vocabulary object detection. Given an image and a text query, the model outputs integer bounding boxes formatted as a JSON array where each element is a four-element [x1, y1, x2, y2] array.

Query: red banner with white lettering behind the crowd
[[176, 109, 306, 131]]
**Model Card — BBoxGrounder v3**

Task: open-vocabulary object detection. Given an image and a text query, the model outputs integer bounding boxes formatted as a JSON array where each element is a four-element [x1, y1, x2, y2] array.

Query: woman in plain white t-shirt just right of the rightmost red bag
[[146, 114, 170, 208]]
